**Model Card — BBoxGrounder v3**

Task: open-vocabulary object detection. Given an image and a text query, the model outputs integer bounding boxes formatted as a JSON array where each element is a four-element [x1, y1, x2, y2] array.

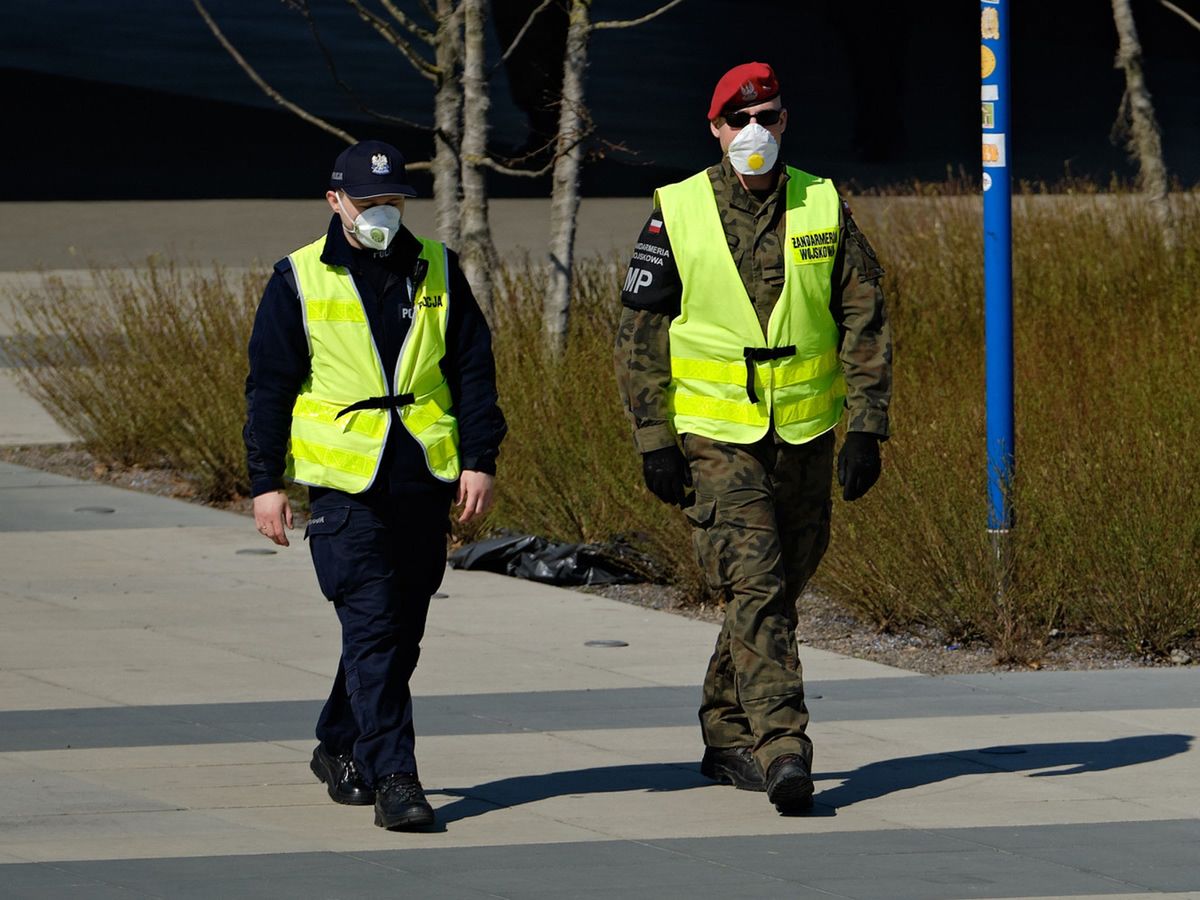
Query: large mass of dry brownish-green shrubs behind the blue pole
[[817, 194, 1200, 660]]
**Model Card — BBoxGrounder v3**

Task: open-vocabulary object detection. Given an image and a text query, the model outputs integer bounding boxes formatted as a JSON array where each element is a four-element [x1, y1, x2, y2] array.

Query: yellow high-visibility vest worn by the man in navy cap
[[287, 238, 460, 493]]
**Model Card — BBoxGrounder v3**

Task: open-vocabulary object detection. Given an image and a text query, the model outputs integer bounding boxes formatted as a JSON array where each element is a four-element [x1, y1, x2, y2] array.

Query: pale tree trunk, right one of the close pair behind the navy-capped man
[[461, 0, 497, 318]]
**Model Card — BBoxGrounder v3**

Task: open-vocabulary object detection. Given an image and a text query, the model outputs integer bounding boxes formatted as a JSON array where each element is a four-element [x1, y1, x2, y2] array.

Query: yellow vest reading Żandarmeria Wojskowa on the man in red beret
[[654, 167, 846, 444]]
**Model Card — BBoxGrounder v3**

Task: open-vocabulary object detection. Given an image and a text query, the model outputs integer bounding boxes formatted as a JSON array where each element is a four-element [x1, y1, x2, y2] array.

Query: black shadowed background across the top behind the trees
[[0, 0, 1200, 199]]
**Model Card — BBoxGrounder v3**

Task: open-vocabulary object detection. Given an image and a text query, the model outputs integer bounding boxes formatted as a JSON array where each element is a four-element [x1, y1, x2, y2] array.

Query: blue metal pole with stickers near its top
[[979, 0, 1015, 539]]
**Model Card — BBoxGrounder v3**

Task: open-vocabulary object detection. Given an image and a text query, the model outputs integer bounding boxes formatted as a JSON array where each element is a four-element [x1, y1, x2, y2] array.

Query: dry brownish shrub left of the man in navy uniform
[[10, 259, 255, 499]]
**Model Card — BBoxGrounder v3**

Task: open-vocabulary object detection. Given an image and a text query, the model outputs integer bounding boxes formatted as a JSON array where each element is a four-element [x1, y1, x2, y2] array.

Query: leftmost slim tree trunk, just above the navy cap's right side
[[431, 0, 462, 248]]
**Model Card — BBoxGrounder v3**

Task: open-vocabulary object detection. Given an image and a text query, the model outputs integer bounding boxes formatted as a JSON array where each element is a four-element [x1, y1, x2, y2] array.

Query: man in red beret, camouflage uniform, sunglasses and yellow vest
[[616, 62, 892, 814]]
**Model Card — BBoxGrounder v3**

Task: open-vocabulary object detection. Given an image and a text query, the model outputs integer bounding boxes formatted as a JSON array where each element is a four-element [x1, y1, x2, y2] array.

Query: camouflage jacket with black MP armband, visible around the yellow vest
[[614, 158, 892, 454]]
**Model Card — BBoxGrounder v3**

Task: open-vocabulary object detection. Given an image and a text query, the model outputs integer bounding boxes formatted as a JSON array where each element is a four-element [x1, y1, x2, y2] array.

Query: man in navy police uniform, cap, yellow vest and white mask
[[244, 140, 505, 829]]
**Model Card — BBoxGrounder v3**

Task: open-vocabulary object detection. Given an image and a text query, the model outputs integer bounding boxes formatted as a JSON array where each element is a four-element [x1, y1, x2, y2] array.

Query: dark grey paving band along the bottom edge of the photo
[[5, 822, 1200, 900]]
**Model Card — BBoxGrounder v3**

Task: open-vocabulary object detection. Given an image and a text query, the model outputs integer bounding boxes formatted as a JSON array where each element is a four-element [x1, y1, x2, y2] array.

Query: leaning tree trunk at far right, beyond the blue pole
[[1112, 0, 1175, 247]]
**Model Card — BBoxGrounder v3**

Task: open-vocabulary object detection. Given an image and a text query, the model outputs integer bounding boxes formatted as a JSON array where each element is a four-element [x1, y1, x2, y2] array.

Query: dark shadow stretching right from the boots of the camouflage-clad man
[[815, 734, 1194, 816]]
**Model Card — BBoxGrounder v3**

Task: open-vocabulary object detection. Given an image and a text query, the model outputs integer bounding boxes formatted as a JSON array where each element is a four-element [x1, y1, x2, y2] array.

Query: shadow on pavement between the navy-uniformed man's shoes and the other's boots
[[428, 762, 714, 822]]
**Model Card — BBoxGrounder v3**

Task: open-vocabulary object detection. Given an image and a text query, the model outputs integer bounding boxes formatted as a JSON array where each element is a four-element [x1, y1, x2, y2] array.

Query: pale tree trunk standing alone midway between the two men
[[542, 0, 592, 353]]
